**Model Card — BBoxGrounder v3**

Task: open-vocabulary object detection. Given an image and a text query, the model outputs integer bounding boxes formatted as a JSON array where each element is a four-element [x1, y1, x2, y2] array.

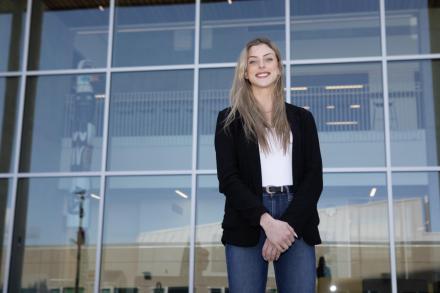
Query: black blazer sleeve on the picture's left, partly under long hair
[[214, 110, 266, 226]]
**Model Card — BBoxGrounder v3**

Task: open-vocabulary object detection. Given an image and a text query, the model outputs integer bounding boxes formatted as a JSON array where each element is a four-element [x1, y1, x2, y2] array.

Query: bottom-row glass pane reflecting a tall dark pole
[[9, 177, 101, 292]]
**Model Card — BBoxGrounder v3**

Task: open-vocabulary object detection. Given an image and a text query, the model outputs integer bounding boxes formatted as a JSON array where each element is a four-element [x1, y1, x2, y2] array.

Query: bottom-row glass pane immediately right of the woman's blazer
[[316, 173, 391, 292]]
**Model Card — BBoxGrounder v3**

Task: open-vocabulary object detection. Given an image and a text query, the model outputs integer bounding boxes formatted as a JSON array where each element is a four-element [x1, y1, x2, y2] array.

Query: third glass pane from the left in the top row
[[113, 0, 195, 66]]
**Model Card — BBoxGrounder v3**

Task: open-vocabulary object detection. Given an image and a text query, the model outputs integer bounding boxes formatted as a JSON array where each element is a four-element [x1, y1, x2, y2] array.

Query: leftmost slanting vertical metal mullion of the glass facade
[[3, 0, 32, 293]]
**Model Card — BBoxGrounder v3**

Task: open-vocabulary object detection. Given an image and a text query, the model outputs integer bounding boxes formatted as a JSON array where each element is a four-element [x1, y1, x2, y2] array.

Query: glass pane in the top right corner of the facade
[[385, 0, 440, 55]]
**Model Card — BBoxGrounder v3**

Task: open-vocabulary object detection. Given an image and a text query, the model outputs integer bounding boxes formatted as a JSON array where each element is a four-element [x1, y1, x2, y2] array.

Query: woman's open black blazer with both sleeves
[[215, 103, 323, 246]]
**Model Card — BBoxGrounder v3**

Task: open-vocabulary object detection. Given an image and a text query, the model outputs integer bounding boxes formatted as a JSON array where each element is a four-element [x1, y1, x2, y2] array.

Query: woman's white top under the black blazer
[[258, 130, 293, 186]]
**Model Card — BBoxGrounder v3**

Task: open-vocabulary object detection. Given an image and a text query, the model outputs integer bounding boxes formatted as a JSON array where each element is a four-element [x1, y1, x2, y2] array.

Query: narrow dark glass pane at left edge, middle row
[[0, 77, 20, 173]]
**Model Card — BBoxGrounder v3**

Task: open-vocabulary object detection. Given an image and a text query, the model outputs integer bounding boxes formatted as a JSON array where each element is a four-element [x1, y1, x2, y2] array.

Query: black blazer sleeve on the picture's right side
[[281, 111, 323, 236]]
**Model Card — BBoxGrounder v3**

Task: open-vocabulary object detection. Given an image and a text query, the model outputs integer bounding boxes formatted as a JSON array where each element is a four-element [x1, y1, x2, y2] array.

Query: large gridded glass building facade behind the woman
[[0, 0, 440, 293]]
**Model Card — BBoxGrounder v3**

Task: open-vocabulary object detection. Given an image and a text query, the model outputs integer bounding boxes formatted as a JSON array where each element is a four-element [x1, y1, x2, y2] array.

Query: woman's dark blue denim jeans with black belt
[[225, 192, 316, 293]]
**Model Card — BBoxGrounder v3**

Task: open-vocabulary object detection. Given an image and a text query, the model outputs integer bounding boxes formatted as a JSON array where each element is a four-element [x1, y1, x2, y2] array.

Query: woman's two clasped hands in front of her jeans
[[260, 213, 298, 261]]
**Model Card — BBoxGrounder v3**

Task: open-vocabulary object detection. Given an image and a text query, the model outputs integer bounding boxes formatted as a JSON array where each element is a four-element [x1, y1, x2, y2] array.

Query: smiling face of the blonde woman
[[245, 44, 280, 89]]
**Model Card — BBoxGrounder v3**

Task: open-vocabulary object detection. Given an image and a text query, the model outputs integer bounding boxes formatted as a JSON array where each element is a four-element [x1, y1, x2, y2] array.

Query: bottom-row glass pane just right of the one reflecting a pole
[[100, 176, 191, 292]]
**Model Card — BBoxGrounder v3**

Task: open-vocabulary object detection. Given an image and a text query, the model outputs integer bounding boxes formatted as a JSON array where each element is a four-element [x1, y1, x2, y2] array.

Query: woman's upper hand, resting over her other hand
[[260, 213, 298, 252]]
